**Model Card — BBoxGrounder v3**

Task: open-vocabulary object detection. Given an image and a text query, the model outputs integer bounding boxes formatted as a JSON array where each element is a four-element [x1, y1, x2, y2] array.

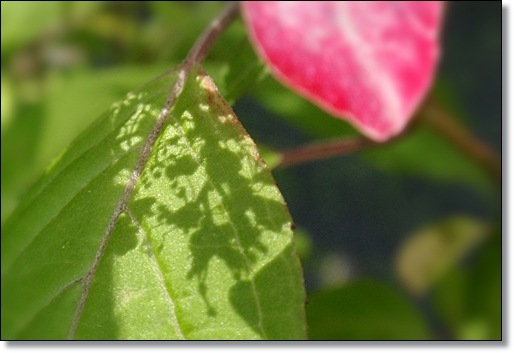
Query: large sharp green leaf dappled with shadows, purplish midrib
[[2, 65, 306, 339]]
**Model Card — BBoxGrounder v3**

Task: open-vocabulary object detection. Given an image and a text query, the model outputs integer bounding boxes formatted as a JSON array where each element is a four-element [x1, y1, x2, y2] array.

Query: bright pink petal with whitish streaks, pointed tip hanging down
[[241, 1, 443, 141]]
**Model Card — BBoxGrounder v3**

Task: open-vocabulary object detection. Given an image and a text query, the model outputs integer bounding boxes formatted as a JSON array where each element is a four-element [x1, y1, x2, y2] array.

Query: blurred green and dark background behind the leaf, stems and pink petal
[[1, 1, 502, 340]]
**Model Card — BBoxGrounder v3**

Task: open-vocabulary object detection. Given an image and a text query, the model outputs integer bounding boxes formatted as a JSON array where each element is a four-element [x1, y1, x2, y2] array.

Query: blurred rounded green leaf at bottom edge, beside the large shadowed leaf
[[306, 281, 430, 340]]
